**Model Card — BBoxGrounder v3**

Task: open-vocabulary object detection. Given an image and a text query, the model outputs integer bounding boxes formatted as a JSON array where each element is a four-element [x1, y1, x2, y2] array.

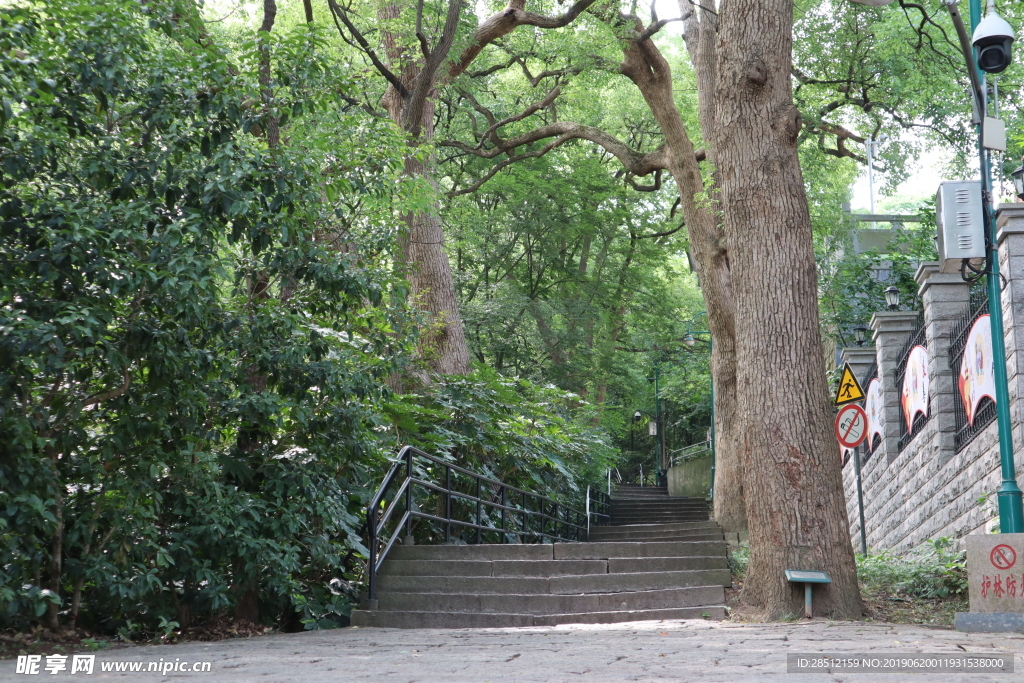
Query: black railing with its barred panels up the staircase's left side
[[367, 445, 610, 599]]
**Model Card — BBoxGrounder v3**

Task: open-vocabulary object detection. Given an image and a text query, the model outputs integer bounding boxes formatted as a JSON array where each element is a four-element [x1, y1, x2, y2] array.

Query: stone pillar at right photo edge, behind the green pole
[[995, 204, 1024, 464]]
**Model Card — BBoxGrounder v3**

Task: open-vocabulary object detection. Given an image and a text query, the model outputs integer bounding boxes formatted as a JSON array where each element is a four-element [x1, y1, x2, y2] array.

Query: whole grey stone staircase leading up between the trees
[[351, 486, 732, 628]]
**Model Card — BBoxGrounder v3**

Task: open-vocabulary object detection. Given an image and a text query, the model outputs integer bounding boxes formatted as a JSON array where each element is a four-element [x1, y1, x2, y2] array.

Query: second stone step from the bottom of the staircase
[[378, 585, 725, 614]]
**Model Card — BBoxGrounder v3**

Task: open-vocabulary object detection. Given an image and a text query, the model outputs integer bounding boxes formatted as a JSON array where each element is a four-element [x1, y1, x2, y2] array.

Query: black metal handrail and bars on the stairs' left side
[[367, 445, 611, 600]]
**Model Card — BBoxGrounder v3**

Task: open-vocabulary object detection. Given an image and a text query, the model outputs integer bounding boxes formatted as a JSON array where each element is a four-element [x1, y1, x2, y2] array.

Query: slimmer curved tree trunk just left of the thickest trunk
[[623, 34, 746, 532]]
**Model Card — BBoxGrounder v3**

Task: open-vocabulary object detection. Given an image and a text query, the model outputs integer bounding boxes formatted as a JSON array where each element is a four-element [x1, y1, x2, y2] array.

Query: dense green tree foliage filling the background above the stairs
[[0, 0, 1024, 630]]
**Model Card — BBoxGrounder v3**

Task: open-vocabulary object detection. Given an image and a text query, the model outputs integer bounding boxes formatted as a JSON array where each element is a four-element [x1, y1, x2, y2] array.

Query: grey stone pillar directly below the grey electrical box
[[914, 261, 971, 467]]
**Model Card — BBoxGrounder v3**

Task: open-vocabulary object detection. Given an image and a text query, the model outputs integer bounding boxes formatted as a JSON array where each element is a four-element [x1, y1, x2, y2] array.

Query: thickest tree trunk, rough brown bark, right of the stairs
[[715, 0, 862, 618]]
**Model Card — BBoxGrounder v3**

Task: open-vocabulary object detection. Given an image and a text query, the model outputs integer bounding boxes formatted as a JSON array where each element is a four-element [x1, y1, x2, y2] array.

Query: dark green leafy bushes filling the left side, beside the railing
[[0, 1, 412, 638]]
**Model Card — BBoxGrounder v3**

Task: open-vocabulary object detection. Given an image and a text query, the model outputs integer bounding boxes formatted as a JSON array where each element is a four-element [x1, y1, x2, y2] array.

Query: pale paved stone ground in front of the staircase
[[0, 621, 1024, 683]]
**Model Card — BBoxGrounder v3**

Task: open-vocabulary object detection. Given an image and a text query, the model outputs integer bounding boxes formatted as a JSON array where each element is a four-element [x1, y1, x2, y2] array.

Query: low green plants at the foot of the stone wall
[[857, 538, 967, 599]]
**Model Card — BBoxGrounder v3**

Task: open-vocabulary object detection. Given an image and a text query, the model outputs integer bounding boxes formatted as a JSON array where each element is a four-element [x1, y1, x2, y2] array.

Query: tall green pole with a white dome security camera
[[945, 0, 1024, 533]]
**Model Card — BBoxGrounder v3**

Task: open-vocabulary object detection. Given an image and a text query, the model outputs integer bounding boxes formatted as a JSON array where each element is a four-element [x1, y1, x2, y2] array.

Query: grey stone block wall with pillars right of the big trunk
[[843, 204, 1024, 553]]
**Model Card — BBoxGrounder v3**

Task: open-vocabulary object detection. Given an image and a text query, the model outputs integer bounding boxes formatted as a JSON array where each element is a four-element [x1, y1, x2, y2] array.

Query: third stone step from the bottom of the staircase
[[378, 569, 732, 595]]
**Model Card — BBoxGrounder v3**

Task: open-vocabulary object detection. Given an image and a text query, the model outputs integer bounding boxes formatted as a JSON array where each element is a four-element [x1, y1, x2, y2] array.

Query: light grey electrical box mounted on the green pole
[[935, 180, 985, 272]]
